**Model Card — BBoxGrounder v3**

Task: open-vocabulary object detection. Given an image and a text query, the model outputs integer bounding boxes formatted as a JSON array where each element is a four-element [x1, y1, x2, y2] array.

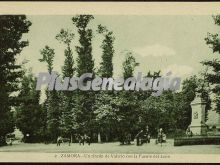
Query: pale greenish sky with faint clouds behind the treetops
[[17, 15, 220, 82]]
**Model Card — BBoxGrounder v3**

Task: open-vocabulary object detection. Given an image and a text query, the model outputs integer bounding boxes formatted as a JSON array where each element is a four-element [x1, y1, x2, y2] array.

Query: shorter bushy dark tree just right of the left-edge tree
[[16, 70, 45, 142]]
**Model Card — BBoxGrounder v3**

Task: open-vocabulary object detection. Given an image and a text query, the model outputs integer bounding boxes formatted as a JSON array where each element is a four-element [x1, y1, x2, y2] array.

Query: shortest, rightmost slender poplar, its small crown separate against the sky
[[117, 51, 139, 144]]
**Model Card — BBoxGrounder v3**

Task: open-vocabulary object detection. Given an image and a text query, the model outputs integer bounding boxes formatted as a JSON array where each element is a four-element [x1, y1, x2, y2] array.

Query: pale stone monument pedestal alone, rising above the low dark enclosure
[[189, 96, 207, 135]]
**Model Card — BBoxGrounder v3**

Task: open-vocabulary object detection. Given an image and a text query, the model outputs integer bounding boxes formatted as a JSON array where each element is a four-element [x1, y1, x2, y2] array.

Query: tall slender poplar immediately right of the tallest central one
[[95, 25, 116, 142]]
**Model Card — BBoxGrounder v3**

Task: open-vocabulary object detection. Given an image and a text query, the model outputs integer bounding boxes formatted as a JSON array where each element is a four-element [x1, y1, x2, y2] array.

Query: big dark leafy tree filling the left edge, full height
[[0, 15, 31, 145]]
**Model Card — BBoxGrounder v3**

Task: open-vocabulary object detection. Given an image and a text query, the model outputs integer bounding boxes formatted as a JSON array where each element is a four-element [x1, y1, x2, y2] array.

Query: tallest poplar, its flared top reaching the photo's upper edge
[[72, 15, 95, 136]]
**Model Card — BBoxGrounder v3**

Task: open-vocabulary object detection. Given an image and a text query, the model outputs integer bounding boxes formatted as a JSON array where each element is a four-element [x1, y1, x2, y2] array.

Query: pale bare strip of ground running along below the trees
[[0, 139, 220, 154]]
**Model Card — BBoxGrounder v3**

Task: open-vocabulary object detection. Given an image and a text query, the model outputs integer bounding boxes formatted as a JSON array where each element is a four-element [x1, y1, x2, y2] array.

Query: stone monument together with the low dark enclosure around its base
[[174, 95, 220, 146]]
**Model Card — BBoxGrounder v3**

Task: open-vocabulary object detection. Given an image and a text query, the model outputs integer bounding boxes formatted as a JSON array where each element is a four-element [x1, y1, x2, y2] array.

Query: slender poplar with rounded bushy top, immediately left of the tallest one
[[56, 29, 76, 141]]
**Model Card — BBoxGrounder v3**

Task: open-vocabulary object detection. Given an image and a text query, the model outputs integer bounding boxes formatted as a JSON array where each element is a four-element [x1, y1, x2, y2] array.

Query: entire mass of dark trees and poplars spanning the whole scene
[[0, 15, 220, 144]]
